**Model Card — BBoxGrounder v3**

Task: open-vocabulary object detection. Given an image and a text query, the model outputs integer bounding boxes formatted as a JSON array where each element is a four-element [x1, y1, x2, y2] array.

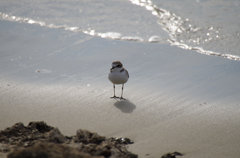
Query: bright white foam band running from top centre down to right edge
[[129, 0, 240, 61]]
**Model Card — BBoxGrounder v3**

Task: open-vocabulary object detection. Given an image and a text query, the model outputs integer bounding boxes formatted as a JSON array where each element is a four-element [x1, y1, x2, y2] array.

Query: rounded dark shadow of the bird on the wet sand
[[114, 99, 136, 113]]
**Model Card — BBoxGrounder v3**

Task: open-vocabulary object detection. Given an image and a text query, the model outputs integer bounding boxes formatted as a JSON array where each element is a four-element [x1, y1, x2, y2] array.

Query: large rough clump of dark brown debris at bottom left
[[0, 122, 138, 158]]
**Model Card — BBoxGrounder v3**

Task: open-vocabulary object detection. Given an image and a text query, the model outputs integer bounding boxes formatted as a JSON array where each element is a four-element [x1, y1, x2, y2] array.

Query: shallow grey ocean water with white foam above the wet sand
[[0, 0, 240, 60]]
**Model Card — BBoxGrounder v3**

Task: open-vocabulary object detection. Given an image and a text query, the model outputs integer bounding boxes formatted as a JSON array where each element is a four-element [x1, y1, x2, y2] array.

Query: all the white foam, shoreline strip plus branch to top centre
[[0, 10, 240, 61]]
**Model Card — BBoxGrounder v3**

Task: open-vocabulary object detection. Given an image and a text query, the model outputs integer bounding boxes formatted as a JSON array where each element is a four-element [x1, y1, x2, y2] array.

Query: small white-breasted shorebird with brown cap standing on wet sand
[[108, 61, 129, 99]]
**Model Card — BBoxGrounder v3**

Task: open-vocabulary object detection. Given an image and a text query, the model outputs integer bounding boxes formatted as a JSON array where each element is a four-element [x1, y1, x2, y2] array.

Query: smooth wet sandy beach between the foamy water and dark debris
[[0, 16, 240, 158]]
